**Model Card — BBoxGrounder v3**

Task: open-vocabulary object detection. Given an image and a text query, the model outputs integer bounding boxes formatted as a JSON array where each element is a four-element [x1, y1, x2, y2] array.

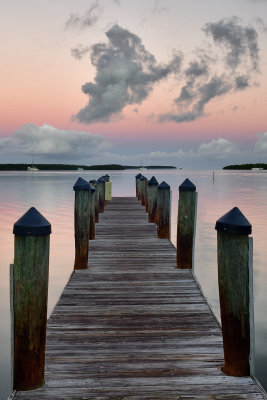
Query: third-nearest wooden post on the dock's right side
[[157, 181, 171, 239]]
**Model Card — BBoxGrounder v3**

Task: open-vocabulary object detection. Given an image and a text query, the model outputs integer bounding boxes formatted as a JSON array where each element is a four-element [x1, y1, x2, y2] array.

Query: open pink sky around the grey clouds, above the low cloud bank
[[0, 0, 267, 166]]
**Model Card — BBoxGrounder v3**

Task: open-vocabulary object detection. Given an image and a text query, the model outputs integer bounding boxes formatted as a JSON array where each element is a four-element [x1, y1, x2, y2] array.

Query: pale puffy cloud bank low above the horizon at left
[[0, 124, 110, 160]]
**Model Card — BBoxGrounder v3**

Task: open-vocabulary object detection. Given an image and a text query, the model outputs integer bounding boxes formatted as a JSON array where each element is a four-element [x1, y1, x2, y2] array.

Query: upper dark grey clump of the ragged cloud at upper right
[[203, 17, 259, 70]]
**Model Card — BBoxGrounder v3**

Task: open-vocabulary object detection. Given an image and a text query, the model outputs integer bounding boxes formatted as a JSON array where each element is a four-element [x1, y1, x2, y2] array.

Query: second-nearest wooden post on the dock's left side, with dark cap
[[73, 178, 90, 270]]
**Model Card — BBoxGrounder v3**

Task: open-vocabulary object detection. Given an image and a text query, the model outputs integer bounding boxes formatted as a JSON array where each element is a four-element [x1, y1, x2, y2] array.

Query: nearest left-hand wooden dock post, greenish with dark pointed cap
[[10, 207, 51, 390]]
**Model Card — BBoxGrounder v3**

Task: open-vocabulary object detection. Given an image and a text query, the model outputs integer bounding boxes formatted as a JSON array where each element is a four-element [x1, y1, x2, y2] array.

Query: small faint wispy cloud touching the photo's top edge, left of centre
[[65, 0, 101, 29]]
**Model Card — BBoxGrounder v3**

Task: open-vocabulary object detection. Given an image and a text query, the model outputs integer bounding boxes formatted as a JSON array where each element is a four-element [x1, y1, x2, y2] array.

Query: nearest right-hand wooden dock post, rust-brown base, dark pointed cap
[[215, 207, 254, 376]]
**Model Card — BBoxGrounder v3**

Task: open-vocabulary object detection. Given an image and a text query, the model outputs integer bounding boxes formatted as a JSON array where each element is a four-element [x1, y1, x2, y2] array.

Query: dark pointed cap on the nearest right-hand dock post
[[215, 207, 252, 235]]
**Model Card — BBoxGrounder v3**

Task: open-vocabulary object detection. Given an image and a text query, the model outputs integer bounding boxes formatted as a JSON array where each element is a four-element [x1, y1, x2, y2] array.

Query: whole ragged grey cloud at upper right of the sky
[[159, 17, 259, 123]]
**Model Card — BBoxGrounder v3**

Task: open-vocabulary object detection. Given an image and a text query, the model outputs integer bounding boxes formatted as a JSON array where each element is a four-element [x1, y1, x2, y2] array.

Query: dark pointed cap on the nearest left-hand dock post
[[13, 207, 51, 236]]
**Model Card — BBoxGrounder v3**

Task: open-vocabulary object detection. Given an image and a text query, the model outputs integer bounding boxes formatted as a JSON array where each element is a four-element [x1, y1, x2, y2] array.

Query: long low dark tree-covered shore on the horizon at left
[[0, 164, 176, 171]]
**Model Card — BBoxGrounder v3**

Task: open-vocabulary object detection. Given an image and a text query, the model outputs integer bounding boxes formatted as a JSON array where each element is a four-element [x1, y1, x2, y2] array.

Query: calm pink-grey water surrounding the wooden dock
[[0, 170, 267, 399]]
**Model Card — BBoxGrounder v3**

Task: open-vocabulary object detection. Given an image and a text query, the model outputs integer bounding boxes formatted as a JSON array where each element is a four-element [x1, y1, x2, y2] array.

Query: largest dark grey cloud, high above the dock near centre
[[74, 25, 182, 124]]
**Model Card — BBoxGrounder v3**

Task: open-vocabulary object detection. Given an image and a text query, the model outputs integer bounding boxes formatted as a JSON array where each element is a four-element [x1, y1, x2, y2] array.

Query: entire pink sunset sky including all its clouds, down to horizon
[[0, 0, 267, 169]]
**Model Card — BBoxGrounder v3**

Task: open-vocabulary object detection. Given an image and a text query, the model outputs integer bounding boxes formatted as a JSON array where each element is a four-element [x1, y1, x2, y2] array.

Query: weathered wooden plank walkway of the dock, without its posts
[[13, 197, 265, 400]]
